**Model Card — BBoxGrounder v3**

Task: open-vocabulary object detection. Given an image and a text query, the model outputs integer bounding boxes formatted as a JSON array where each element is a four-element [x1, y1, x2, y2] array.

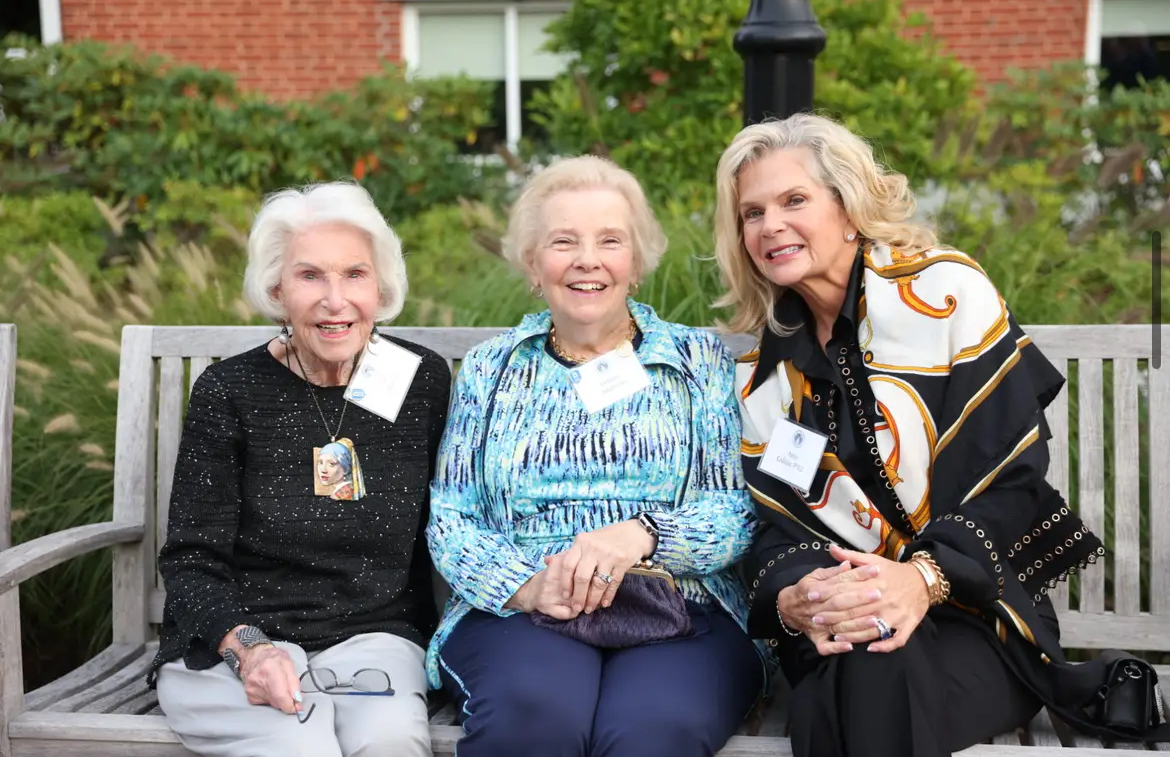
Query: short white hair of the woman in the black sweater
[[243, 181, 407, 323]]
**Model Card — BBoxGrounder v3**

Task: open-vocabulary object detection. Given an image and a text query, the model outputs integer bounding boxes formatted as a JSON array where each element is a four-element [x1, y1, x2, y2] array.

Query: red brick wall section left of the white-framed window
[[61, 0, 401, 98]]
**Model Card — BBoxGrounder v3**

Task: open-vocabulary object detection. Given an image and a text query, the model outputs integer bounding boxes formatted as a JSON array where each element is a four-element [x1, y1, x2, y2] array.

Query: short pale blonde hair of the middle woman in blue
[[502, 156, 667, 283]]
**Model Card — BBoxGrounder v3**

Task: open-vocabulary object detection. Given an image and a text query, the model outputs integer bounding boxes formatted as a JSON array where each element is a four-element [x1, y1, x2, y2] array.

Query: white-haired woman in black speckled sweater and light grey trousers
[[149, 183, 450, 757]]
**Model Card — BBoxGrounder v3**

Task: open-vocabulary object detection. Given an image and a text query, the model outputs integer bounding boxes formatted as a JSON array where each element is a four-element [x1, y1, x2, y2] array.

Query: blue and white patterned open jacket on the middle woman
[[427, 300, 757, 688]]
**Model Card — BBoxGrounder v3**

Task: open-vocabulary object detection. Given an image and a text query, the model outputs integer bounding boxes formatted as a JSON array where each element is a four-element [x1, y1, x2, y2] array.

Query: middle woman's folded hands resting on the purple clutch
[[505, 521, 655, 620]]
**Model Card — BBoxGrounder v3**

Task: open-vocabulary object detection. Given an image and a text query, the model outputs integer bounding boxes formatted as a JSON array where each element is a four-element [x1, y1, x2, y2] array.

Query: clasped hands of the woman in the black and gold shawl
[[776, 544, 930, 655]]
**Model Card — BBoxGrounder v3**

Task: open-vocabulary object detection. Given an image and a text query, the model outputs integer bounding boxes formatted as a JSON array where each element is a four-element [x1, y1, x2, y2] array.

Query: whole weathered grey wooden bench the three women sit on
[[0, 325, 1170, 757]]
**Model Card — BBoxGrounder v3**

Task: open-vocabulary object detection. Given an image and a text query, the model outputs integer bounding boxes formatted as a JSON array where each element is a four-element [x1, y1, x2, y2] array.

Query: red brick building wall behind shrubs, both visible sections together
[[61, 0, 1088, 98]]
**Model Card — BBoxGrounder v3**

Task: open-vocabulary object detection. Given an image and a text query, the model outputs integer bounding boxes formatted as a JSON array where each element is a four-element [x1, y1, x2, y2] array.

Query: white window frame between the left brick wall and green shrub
[[400, 0, 572, 152]]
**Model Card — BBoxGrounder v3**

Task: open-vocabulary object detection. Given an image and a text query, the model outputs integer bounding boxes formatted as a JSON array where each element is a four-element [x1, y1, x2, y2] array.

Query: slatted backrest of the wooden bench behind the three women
[[115, 325, 1170, 649]]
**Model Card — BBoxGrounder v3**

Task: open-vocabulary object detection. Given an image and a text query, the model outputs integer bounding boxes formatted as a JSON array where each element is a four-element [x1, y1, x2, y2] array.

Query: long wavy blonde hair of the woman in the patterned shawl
[[715, 113, 940, 335]]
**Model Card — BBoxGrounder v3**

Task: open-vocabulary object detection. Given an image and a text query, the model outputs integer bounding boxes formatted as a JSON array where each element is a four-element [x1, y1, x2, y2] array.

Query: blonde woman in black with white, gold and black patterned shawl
[[702, 115, 1103, 757]]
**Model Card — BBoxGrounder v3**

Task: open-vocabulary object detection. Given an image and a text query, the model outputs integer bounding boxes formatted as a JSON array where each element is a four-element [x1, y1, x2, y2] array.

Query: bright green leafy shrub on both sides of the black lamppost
[[531, 0, 975, 209]]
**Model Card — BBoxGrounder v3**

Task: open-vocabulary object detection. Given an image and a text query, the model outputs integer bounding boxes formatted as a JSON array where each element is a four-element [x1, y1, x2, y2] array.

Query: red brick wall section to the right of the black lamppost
[[904, 0, 1088, 83]]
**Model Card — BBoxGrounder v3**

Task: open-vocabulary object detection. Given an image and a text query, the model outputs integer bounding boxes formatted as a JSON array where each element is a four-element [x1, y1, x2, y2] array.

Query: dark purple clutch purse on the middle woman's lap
[[531, 566, 694, 649]]
